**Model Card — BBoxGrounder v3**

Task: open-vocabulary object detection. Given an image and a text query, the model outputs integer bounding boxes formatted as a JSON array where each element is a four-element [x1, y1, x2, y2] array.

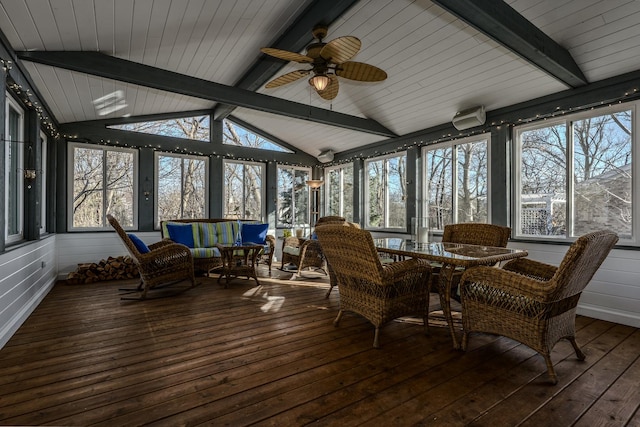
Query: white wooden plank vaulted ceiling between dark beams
[[0, 0, 640, 156]]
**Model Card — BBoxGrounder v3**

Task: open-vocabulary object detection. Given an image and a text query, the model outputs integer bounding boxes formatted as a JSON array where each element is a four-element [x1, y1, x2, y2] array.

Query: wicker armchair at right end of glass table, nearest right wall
[[460, 230, 618, 384]]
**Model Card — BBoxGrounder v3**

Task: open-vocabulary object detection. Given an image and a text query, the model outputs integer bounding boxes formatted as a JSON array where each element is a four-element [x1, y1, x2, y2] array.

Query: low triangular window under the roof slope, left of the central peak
[[107, 115, 211, 142]]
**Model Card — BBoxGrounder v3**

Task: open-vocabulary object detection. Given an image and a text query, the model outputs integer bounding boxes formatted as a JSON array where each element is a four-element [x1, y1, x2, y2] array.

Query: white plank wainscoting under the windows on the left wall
[[0, 235, 58, 348]]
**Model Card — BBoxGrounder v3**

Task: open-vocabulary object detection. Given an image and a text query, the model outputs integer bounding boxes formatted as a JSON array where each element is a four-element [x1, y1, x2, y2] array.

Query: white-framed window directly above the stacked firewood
[[69, 143, 138, 230]]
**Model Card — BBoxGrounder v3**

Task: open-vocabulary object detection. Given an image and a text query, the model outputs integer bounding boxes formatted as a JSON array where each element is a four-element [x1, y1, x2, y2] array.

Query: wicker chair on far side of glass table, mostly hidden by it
[[431, 222, 511, 299]]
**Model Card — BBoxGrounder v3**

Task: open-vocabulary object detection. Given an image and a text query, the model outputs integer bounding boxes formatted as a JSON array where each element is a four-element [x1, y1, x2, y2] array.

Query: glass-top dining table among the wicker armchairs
[[373, 237, 528, 349]]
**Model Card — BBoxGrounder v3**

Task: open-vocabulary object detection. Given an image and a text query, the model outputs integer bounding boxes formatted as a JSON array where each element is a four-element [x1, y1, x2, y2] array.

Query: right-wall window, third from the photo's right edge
[[364, 153, 407, 229]]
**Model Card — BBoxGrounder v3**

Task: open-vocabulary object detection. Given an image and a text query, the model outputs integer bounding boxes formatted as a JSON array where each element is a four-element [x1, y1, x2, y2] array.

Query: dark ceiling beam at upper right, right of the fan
[[432, 0, 588, 87]]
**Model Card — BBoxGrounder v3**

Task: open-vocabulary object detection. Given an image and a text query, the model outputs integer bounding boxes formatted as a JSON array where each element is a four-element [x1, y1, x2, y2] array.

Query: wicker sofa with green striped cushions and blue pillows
[[160, 218, 276, 272]]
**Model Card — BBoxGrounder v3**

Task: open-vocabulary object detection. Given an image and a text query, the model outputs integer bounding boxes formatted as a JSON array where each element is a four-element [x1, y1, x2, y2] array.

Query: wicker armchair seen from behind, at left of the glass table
[[316, 224, 431, 348]]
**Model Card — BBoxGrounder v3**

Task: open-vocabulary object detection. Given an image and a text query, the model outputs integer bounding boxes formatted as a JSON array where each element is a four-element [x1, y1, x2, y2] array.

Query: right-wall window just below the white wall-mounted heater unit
[[422, 135, 490, 230]]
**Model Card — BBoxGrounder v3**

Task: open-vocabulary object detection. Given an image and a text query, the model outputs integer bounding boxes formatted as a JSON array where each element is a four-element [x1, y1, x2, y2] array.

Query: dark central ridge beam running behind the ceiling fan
[[213, 0, 359, 120]]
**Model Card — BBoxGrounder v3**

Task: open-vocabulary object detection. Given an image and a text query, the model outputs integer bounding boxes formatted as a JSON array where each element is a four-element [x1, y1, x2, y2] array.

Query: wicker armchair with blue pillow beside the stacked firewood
[[107, 215, 196, 299]]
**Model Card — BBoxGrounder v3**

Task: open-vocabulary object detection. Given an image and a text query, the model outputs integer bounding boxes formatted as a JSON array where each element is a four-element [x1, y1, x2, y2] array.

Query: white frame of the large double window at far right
[[511, 102, 640, 246]]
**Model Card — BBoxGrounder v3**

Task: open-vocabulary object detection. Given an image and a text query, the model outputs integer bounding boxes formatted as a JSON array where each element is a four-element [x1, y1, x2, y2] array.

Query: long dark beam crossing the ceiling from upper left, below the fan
[[16, 51, 395, 137]]
